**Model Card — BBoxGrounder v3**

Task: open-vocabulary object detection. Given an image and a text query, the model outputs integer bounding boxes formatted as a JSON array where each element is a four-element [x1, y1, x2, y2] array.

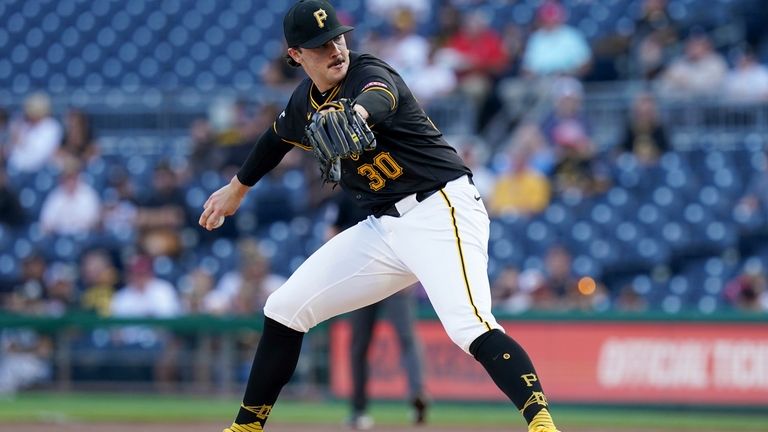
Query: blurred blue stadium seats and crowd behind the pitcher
[[0, 0, 768, 394]]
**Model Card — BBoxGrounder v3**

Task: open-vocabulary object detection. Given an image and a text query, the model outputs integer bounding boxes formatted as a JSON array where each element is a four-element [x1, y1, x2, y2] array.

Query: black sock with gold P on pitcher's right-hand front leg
[[469, 329, 556, 431]]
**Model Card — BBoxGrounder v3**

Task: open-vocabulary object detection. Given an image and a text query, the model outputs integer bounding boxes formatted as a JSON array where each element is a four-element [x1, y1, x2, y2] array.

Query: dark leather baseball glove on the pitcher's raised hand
[[304, 99, 376, 183]]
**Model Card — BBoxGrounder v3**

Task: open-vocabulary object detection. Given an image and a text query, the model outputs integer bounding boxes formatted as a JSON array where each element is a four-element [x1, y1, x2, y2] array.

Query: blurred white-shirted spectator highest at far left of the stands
[[8, 93, 63, 172]]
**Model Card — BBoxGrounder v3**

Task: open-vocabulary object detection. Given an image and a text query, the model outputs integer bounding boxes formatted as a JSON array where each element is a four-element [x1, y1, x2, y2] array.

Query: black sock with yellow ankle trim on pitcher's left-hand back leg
[[229, 318, 304, 432]]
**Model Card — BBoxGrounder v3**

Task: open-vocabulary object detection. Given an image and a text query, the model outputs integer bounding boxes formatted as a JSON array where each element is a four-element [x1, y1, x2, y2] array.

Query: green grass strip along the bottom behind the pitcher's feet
[[0, 393, 768, 431]]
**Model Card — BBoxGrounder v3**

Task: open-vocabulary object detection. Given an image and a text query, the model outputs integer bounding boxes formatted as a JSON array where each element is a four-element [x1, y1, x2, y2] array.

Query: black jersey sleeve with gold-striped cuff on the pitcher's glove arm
[[349, 65, 399, 125]]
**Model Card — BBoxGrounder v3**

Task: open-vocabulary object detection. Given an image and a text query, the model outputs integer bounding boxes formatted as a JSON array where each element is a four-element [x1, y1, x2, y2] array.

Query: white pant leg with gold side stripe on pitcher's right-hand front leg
[[390, 183, 501, 353]]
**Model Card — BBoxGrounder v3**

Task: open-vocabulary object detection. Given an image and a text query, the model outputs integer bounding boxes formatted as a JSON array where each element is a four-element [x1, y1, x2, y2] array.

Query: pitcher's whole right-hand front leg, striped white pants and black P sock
[[395, 183, 556, 432]]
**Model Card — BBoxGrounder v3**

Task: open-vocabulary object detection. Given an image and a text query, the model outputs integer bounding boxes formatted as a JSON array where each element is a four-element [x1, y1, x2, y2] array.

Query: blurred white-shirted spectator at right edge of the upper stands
[[723, 50, 768, 102]]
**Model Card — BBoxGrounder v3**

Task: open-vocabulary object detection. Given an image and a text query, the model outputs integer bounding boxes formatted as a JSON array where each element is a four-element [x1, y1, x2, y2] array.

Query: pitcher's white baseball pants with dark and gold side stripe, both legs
[[264, 176, 503, 353]]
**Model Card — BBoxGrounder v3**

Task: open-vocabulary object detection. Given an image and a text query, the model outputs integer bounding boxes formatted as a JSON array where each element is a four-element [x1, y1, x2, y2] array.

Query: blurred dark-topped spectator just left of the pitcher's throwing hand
[[136, 162, 187, 256]]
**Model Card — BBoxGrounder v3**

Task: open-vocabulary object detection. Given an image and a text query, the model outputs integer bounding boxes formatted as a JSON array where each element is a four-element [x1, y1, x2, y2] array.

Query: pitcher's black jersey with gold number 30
[[274, 53, 470, 213]]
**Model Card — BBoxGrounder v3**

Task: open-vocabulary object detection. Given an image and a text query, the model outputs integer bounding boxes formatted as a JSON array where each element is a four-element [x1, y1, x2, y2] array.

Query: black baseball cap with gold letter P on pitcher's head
[[283, 0, 354, 48]]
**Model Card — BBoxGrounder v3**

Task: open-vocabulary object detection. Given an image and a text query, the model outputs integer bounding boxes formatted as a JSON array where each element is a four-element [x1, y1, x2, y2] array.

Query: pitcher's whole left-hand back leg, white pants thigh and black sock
[[226, 223, 414, 432]]
